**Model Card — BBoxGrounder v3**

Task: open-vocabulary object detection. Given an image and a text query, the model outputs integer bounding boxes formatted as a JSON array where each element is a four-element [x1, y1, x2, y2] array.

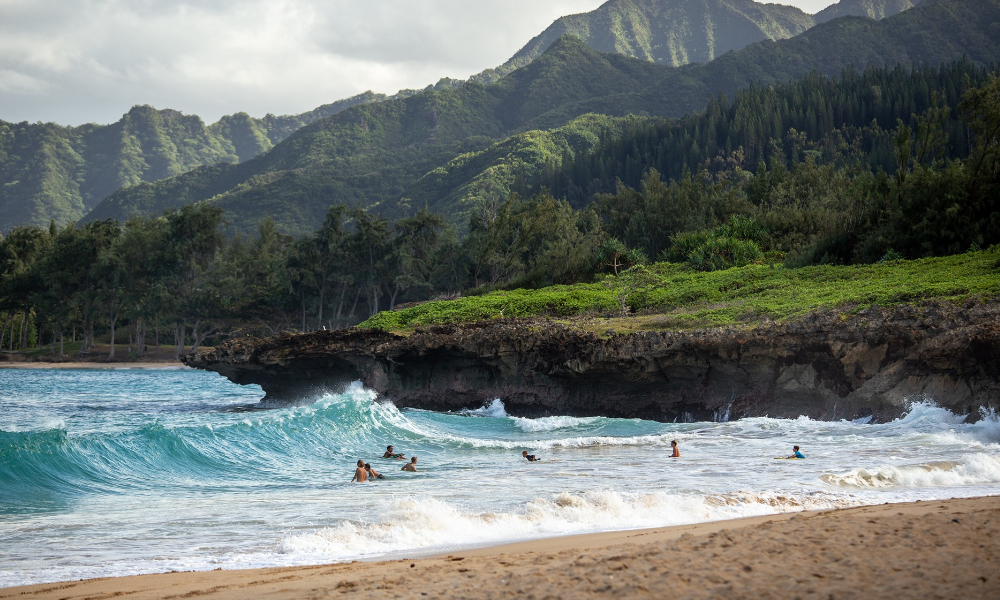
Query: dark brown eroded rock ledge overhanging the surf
[[183, 301, 1000, 421]]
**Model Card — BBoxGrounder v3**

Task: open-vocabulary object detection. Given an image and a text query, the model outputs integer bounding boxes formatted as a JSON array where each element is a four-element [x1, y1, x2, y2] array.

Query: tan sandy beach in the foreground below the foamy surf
[[0, 497, 1000, 600]]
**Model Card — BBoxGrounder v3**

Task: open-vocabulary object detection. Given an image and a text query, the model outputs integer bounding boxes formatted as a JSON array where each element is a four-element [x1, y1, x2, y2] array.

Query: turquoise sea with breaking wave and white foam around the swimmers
[[0, 369, 1000, 587]]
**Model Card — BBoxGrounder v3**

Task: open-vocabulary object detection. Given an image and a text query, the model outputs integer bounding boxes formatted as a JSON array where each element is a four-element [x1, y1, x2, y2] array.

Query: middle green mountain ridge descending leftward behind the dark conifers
[[87, 0, 1000, 233]]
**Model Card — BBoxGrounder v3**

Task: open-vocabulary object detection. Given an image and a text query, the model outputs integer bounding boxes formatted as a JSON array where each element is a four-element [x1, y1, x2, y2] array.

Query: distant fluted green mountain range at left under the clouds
[[0, 92, 385, 231]]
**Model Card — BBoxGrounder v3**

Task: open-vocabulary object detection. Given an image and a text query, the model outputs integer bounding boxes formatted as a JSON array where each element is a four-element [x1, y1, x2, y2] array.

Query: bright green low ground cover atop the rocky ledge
[[360, 248, 1000, 331]]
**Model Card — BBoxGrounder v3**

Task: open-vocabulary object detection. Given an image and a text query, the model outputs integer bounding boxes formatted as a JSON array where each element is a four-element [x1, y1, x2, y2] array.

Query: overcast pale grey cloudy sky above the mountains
[[0, 0, 833, 125]]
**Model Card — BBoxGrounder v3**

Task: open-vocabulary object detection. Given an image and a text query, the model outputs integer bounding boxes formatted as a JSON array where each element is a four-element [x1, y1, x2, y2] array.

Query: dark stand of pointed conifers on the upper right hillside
[[533, 60, 989, 207]]
